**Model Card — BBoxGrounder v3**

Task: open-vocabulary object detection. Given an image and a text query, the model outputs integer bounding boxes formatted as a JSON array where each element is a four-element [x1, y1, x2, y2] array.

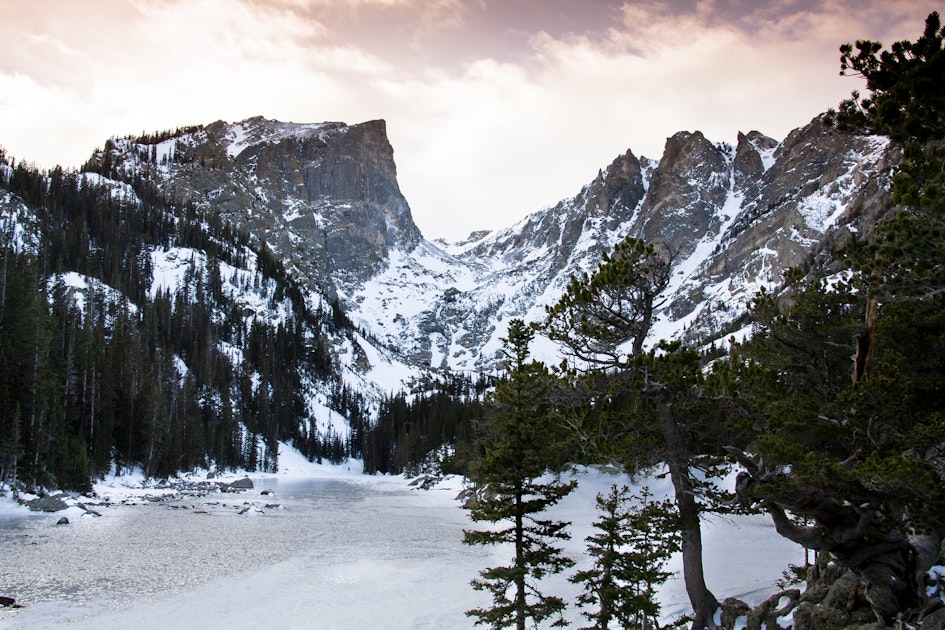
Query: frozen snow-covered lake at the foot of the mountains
[[0, 473, 803, 630]]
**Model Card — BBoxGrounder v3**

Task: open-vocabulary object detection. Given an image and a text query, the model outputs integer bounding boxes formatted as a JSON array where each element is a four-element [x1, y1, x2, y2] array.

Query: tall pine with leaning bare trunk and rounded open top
[[542, 239, 726, 628]]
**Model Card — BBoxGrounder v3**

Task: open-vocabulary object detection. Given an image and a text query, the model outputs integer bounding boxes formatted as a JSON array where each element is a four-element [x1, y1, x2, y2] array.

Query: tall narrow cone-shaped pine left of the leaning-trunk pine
[[463, 320, 575, 630]]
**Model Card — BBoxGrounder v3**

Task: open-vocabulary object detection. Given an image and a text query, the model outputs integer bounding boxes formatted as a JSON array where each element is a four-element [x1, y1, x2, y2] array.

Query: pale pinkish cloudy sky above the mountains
[[0, 0, 940, 238]]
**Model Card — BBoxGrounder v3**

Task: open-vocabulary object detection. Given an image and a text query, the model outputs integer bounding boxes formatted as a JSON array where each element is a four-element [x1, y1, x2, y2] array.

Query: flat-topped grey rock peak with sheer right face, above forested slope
[[93, 118, 421, 296]]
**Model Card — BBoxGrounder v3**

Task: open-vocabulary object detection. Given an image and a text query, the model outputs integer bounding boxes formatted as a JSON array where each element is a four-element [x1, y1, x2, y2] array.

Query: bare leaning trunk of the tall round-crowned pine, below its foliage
[[657, 402, 719, 630]]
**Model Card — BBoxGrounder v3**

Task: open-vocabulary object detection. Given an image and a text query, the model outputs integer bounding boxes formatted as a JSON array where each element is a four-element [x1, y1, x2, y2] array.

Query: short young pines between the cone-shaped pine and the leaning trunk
[[571, 485, 679, 630]]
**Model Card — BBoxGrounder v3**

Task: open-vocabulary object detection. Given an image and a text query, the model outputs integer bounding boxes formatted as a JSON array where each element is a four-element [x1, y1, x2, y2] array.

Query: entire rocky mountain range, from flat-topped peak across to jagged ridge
[[99, 118, 894, 380]]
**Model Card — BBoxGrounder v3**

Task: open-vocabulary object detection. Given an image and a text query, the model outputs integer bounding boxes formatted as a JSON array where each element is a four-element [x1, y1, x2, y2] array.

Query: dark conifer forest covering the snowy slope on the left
[[0, 147, 358, 489]]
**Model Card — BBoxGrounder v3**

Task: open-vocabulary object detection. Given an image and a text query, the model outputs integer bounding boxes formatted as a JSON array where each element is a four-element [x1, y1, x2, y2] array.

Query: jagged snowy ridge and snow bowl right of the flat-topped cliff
[[346, 119, 888, 370]]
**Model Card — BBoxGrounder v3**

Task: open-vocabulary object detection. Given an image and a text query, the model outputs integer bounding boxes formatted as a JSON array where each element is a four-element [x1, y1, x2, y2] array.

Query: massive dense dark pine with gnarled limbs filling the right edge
[[734, 13, 945, 624]]
